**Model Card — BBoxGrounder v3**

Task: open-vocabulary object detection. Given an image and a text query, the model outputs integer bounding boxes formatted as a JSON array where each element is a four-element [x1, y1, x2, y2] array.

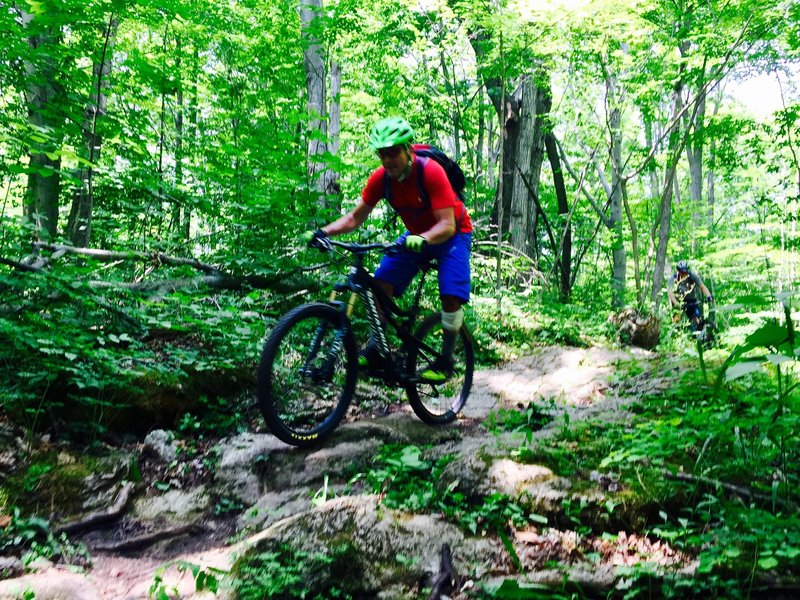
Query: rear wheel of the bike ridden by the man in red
[[405, 315, 475, 425]]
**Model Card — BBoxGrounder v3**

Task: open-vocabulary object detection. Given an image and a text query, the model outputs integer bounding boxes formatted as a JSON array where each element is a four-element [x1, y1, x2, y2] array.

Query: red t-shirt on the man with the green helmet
[[361, 156, 472, 235]]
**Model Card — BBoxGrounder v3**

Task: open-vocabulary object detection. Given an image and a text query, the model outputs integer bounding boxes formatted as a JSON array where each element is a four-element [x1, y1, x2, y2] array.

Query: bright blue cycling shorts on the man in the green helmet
[[375, 231, 472, 304]]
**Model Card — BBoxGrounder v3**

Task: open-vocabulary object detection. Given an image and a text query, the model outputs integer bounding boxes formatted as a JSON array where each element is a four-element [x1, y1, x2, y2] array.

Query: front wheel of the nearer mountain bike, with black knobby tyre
[[257, 303, 358, 446]]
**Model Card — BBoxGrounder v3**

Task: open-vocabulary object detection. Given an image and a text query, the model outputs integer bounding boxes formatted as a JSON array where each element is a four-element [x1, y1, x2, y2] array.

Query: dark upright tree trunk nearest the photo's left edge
[[20, 12, 63, 238]]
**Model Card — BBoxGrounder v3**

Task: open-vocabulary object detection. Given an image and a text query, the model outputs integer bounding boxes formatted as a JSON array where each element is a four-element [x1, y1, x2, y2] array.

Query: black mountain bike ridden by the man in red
[[257, 240, 475, 447]]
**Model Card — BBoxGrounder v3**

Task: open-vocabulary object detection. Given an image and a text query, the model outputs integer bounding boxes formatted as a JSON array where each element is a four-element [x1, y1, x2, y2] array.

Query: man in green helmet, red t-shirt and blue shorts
[[303, 117, 472, 382]]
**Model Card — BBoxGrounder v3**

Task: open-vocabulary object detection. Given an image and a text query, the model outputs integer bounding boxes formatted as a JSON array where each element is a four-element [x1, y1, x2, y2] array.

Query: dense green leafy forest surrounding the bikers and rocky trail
[[0, 0, 800, 599]]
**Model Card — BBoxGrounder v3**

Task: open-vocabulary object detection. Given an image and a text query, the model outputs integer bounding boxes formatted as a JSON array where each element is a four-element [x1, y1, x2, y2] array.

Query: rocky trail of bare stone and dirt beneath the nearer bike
[[0, 347, 691, 600]]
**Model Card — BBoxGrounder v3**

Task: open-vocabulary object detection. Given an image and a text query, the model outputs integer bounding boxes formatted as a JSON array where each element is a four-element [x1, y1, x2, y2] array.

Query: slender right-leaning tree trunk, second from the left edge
[[67, 16, 118, 246]]
